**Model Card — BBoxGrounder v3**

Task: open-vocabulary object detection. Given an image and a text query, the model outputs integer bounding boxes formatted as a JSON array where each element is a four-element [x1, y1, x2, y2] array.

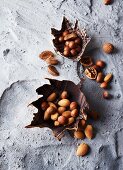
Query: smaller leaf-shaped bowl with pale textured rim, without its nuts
[[51, 17, 91, 61]]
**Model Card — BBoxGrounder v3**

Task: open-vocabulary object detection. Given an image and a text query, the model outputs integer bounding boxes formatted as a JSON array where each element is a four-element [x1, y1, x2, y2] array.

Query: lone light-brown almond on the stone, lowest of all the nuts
[[76, 143, 89, 156]]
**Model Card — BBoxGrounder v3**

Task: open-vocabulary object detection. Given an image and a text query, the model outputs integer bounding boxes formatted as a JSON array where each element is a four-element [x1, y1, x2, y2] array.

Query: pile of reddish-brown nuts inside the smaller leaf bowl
[[58, 30, 82, 57]]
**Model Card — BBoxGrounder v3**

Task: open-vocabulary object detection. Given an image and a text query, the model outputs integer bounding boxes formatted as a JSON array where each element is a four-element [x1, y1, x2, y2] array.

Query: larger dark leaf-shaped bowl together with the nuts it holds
[[26, 79, 89, 140]]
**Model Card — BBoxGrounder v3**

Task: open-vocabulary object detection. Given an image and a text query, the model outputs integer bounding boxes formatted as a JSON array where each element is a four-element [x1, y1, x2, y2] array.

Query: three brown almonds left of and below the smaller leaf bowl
[[39, 51, 59, 76]]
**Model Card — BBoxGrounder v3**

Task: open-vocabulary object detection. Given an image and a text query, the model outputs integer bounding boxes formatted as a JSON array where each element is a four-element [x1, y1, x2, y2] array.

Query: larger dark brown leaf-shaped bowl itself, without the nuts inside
[[26, 79, 89, 140]]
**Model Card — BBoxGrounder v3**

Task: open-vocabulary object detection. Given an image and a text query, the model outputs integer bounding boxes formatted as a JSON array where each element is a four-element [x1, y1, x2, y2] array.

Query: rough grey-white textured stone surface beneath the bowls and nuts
[[0, 0, 123, 170]]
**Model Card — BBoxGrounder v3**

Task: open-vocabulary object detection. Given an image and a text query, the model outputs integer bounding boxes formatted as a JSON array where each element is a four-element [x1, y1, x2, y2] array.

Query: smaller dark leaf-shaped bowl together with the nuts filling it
[[51, 17, 90, 61]]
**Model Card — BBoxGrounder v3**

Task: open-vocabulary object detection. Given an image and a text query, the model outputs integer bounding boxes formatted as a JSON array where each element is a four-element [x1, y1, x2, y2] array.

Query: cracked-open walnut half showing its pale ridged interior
[[84, 67, 97, 79]]
